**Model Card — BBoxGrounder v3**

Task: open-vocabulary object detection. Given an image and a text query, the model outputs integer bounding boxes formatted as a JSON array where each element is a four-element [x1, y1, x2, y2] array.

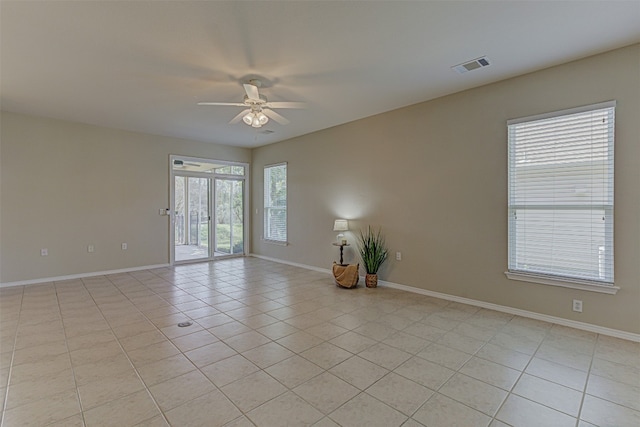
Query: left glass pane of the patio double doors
[[174, 176, 211, 261]]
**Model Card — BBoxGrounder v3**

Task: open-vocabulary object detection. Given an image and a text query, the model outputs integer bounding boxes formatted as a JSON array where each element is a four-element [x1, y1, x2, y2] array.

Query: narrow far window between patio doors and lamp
[[264, 163, 287, 243]]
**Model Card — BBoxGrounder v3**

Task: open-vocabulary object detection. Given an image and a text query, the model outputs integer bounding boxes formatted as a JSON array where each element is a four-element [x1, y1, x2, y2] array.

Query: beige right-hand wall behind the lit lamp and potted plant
[[252, 45, 640, 333]]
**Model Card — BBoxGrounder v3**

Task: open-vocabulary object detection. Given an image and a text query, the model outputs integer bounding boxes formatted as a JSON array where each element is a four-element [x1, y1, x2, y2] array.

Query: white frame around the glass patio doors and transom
[[169, 154, 251, 265]]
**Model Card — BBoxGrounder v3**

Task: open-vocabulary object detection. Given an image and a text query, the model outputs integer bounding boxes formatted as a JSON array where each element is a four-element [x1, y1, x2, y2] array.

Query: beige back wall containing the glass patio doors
[[0, 113, 251, 283]]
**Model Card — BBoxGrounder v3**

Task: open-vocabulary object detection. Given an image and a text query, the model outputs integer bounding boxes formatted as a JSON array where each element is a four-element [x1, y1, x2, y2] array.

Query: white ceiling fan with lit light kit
[[198, 79, 305, 128]]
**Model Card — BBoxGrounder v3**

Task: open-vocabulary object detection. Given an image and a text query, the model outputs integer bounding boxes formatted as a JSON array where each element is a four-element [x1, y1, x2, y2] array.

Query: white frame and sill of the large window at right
[[505, 101, 620, 294]]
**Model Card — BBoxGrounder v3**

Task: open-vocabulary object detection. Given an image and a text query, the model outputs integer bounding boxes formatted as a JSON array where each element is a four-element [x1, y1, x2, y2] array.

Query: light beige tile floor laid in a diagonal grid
[[0, 258, 640, 427]]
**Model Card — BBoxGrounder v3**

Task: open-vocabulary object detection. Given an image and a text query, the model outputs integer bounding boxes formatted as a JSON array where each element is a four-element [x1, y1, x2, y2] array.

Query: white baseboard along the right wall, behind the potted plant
[[251, 254, 640, 342]]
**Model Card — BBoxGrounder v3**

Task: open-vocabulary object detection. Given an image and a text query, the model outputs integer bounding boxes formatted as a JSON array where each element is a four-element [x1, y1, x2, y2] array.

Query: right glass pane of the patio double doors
[[214, 178, 244, 256]]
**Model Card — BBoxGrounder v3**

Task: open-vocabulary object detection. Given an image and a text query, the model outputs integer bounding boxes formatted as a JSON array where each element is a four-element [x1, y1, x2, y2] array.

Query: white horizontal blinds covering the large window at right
[[508, 102, 615, 284]]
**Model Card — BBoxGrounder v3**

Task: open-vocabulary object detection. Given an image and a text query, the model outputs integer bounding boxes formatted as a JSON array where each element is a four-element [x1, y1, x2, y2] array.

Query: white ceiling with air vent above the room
[[0, 0, 640, 147]]
